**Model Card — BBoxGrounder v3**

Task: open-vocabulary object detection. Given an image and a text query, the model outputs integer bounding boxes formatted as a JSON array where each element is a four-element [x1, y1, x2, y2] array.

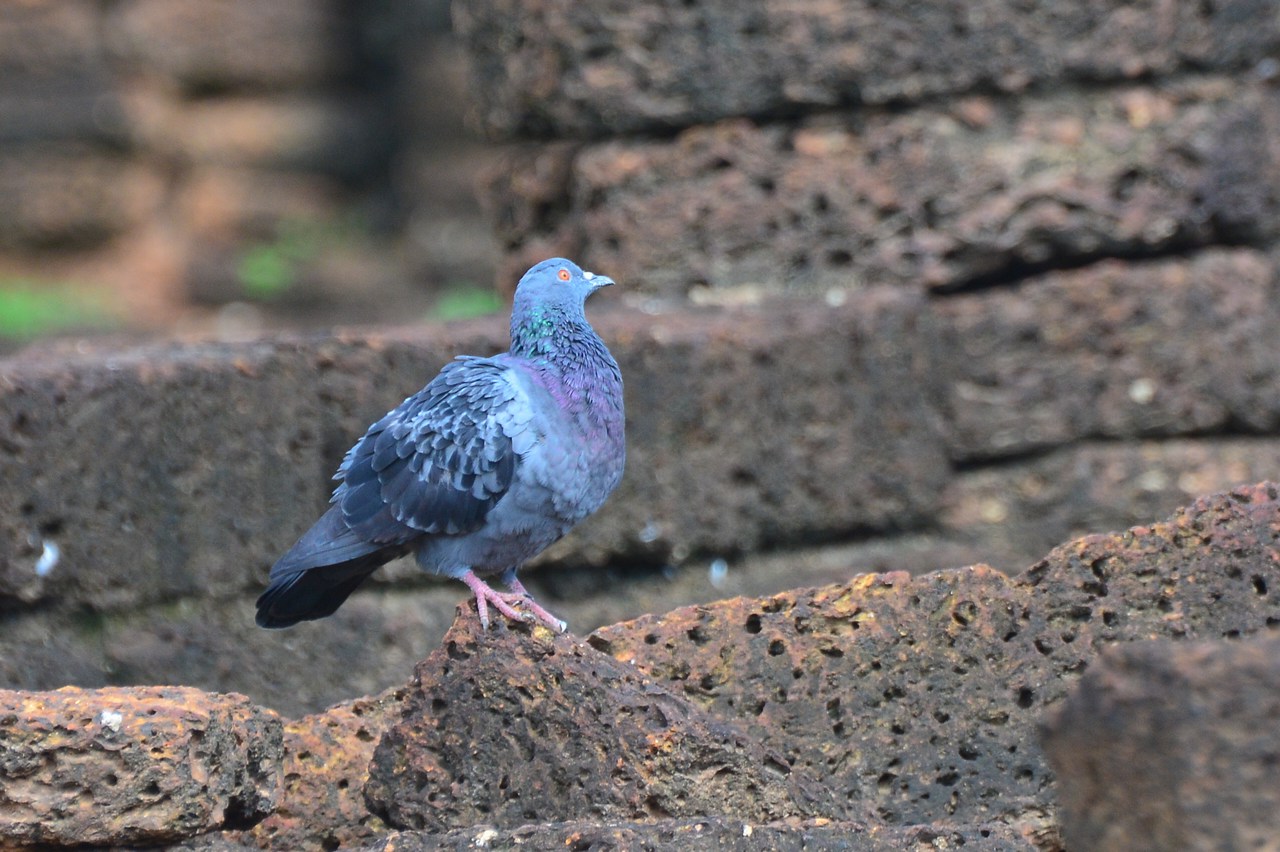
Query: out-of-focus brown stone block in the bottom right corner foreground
[[1044, 634, 1280, 852]]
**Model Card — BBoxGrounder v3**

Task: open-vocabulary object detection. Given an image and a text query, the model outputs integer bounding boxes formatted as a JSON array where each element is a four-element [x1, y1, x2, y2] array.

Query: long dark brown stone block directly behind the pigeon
[[0, 292, 947, 611]]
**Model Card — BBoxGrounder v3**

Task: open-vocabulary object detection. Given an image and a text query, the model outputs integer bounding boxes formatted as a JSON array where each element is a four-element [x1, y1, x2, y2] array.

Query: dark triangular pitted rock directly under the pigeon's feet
[[365, 608, 831, 830]]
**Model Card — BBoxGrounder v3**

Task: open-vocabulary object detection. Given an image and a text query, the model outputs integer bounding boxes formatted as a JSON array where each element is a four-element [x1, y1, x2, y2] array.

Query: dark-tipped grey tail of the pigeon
[[255, 508, 406, 628]]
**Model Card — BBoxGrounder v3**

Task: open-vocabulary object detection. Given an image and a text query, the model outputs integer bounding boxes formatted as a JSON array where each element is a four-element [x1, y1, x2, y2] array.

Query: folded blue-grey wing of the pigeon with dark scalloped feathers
[[333, 356, 538, 545]]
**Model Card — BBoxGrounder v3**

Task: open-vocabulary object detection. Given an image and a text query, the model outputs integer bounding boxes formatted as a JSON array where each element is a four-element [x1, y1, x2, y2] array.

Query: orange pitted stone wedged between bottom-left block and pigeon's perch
[[235, 687, 406, 852]]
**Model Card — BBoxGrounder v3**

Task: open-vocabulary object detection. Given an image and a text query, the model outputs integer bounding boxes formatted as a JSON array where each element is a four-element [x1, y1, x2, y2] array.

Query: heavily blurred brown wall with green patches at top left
[[0, 0, 497, 335]]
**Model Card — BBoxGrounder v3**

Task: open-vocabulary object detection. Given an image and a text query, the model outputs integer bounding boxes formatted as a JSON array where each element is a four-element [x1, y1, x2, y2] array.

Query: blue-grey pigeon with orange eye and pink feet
[[256, 257, 626, 633]]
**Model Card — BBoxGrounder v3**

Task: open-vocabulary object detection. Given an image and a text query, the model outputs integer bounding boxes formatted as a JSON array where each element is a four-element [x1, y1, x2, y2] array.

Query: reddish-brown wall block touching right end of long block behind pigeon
[[936, 249, 1280, 461]]
